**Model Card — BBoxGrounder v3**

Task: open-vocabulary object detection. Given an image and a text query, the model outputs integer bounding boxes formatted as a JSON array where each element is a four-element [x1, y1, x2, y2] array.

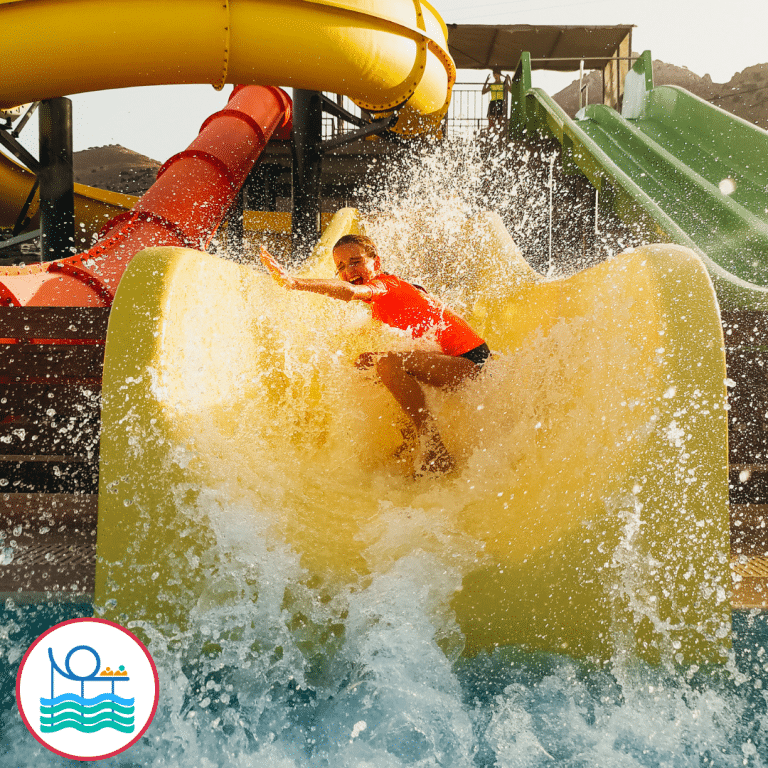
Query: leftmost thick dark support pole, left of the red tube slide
[[38, 97, 76, 261]]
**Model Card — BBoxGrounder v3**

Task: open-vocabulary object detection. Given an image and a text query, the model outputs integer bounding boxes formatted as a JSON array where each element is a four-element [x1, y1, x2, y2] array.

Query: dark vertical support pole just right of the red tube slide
[[291, 88, 323, 261]]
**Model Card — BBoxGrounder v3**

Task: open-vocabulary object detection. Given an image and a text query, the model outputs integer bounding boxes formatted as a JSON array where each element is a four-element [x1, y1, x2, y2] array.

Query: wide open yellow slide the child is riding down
[[96, 210, 730, 661]]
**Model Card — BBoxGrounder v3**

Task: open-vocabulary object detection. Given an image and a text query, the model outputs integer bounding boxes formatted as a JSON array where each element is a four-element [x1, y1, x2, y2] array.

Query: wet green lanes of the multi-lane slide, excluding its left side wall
[[577, 86, 768, 286]]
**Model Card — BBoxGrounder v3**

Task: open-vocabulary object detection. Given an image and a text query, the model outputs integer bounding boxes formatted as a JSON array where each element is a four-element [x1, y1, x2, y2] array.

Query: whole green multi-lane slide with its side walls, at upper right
[[511, 51, 768, 309]]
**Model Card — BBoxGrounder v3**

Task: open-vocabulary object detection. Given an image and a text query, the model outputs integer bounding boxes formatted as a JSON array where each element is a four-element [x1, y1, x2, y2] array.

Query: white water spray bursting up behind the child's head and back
[[357, 138, 648, 284]]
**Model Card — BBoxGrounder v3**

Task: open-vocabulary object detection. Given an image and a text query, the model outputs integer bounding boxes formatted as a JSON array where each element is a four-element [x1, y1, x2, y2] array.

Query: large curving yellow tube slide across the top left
[[0, 0, 455, 133]]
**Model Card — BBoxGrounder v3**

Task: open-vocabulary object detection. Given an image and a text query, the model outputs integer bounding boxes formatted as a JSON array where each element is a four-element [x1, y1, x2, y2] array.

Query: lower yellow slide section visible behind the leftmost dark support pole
[[0, 152, 139, 237]]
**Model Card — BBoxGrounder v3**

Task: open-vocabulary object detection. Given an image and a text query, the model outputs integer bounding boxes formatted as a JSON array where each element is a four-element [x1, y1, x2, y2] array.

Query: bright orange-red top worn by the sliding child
[[368, 274, 485, 357]]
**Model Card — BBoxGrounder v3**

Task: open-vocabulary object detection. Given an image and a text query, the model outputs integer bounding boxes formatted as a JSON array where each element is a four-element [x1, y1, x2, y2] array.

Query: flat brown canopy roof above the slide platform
[[448, 24, 634, 72]]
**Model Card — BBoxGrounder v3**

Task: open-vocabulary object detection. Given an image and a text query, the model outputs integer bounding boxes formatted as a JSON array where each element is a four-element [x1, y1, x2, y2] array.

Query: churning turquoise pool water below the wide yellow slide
[[0, 604, 768, 768]]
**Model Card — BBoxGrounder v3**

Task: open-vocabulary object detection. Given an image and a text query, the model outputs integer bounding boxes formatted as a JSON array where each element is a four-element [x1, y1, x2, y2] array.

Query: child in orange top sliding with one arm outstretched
[[261, 235, 490, 474]]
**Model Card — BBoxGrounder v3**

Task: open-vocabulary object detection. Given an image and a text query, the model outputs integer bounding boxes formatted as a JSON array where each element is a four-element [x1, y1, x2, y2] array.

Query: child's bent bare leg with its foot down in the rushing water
[[375, 352, 476, 472]]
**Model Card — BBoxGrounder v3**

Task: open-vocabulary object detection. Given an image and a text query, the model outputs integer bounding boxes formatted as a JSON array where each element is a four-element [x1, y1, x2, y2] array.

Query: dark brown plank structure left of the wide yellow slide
[[0, 307, 109, 601]]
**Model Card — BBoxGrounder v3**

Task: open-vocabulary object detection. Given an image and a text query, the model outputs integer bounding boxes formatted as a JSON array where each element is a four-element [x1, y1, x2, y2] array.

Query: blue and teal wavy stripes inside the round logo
[[40, 693, 134, 733]]
